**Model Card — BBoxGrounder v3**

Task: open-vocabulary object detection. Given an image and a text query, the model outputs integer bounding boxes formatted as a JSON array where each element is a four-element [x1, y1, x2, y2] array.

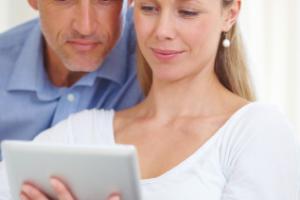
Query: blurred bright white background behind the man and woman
[[0, 0, 300, 137]]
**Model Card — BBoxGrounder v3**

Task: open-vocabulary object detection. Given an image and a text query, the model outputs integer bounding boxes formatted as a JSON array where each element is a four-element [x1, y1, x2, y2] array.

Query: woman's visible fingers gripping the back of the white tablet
[[20, 178, 121, 200]]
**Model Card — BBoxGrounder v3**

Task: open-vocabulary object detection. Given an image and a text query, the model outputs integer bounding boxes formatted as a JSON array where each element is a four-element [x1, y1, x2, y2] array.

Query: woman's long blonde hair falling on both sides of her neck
[[137, 0, 255, 101]]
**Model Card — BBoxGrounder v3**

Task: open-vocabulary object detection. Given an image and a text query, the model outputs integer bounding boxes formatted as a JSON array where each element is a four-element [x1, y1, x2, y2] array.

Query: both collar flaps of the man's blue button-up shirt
[[7, 14, 132, 100]]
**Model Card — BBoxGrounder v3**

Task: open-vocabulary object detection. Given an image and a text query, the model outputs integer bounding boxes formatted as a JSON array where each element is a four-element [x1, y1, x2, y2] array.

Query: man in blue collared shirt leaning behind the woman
[[0, 0, 142, 158]]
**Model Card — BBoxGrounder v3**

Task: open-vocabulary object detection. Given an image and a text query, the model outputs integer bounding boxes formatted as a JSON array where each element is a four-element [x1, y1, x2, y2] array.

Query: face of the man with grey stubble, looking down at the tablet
[[28, 0, 123, 72]]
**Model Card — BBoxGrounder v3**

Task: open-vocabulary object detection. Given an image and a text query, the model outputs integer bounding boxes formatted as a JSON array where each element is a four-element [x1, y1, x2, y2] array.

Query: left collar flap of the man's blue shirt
[[7, 20, 65, 100]]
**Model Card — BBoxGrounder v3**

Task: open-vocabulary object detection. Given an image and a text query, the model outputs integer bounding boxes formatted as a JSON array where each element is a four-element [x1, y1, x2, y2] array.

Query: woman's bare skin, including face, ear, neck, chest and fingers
[[21, 0, 248, 200]]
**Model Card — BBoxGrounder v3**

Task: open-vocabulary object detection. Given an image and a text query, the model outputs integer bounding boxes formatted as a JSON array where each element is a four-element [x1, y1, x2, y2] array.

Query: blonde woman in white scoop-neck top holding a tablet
[[1, 0, 300, 200]]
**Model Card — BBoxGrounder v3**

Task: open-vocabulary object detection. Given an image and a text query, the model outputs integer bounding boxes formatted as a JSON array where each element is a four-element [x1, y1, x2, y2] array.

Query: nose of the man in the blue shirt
[[73, 5, 97, 35]]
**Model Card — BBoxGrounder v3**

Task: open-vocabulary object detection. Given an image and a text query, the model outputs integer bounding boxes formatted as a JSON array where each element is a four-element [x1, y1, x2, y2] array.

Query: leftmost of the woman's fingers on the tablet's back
[[20, 183, 48, 200]]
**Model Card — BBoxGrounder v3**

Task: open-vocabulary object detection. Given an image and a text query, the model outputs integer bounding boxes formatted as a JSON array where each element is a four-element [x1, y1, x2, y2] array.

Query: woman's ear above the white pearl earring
[[223, 0, 242, 32]]
